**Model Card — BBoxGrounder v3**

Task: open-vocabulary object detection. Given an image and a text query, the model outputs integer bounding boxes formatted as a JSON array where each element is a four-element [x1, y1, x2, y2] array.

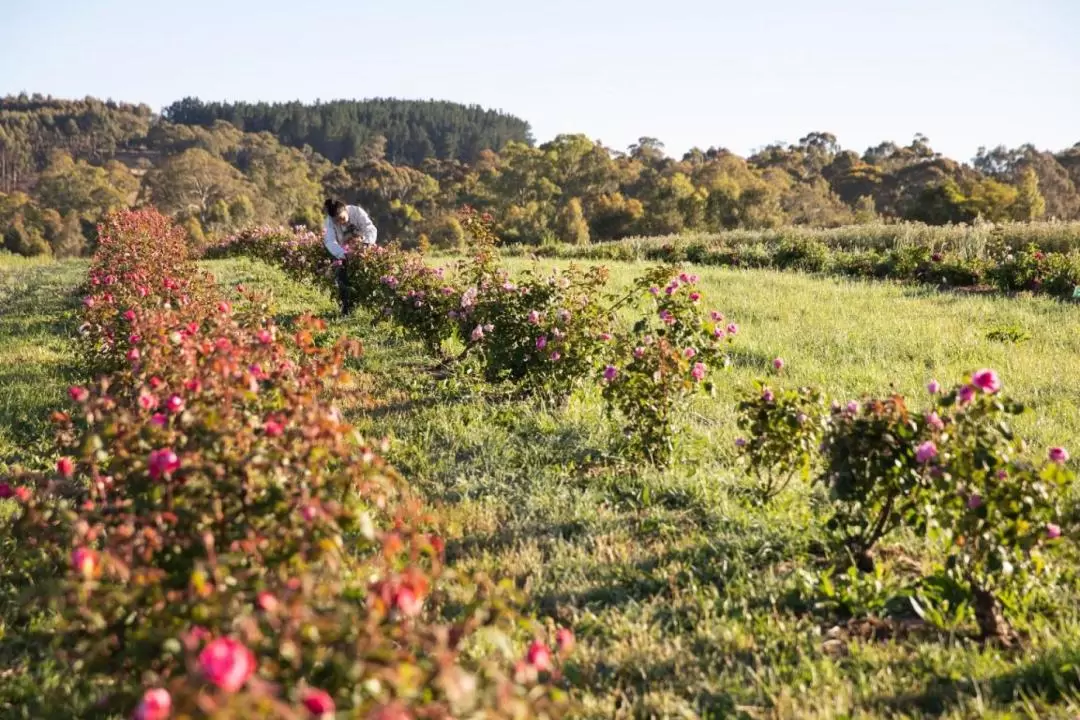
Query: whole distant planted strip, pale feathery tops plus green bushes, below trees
[[511, 222, 1080, 297]]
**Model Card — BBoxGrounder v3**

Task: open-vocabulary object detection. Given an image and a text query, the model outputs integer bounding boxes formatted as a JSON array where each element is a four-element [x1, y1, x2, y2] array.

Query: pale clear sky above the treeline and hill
[[0, 0, 1080, 160]]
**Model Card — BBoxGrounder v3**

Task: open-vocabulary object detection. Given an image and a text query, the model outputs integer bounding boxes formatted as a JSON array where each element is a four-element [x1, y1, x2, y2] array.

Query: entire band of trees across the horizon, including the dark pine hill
[[0, 90, 1080, 255]]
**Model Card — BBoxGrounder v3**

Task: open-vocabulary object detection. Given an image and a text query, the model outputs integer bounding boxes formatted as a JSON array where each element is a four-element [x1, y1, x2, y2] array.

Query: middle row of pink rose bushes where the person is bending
[[208, 208, 739, 463]]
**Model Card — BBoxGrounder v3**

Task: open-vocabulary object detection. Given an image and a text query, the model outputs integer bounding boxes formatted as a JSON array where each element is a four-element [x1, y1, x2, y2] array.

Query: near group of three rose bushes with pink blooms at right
[[737, 369, 1076, 639]]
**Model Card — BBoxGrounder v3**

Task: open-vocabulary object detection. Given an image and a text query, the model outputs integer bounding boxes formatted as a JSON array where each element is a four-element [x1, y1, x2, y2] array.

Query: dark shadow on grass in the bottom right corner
[[874, 649, 1080, 716]]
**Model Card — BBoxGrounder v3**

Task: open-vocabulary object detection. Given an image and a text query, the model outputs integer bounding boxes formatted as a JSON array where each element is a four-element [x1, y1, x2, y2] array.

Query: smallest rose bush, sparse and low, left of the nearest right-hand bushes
[[735, 382, 827, 502]]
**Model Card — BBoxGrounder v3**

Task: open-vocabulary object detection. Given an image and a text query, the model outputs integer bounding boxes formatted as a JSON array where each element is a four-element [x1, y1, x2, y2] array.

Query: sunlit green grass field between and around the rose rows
[[0, 252, 1080, 718]]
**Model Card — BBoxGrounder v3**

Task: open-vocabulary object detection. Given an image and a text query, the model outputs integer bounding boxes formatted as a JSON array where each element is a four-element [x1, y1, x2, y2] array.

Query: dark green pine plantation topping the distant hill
[[162, 97, 532, 166]]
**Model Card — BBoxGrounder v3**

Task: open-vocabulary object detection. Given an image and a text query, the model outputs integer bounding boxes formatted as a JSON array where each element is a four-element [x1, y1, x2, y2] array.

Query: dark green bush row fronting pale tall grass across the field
[[520, 235, 1080, 298]]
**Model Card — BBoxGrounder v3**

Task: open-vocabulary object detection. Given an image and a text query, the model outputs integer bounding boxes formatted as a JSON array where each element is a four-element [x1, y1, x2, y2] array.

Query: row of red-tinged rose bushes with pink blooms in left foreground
[[0, 210, 573, 720]]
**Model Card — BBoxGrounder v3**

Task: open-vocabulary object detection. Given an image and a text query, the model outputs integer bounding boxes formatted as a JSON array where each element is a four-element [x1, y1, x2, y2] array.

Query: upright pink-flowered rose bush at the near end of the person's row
[[603, 268, 739, 464]]
